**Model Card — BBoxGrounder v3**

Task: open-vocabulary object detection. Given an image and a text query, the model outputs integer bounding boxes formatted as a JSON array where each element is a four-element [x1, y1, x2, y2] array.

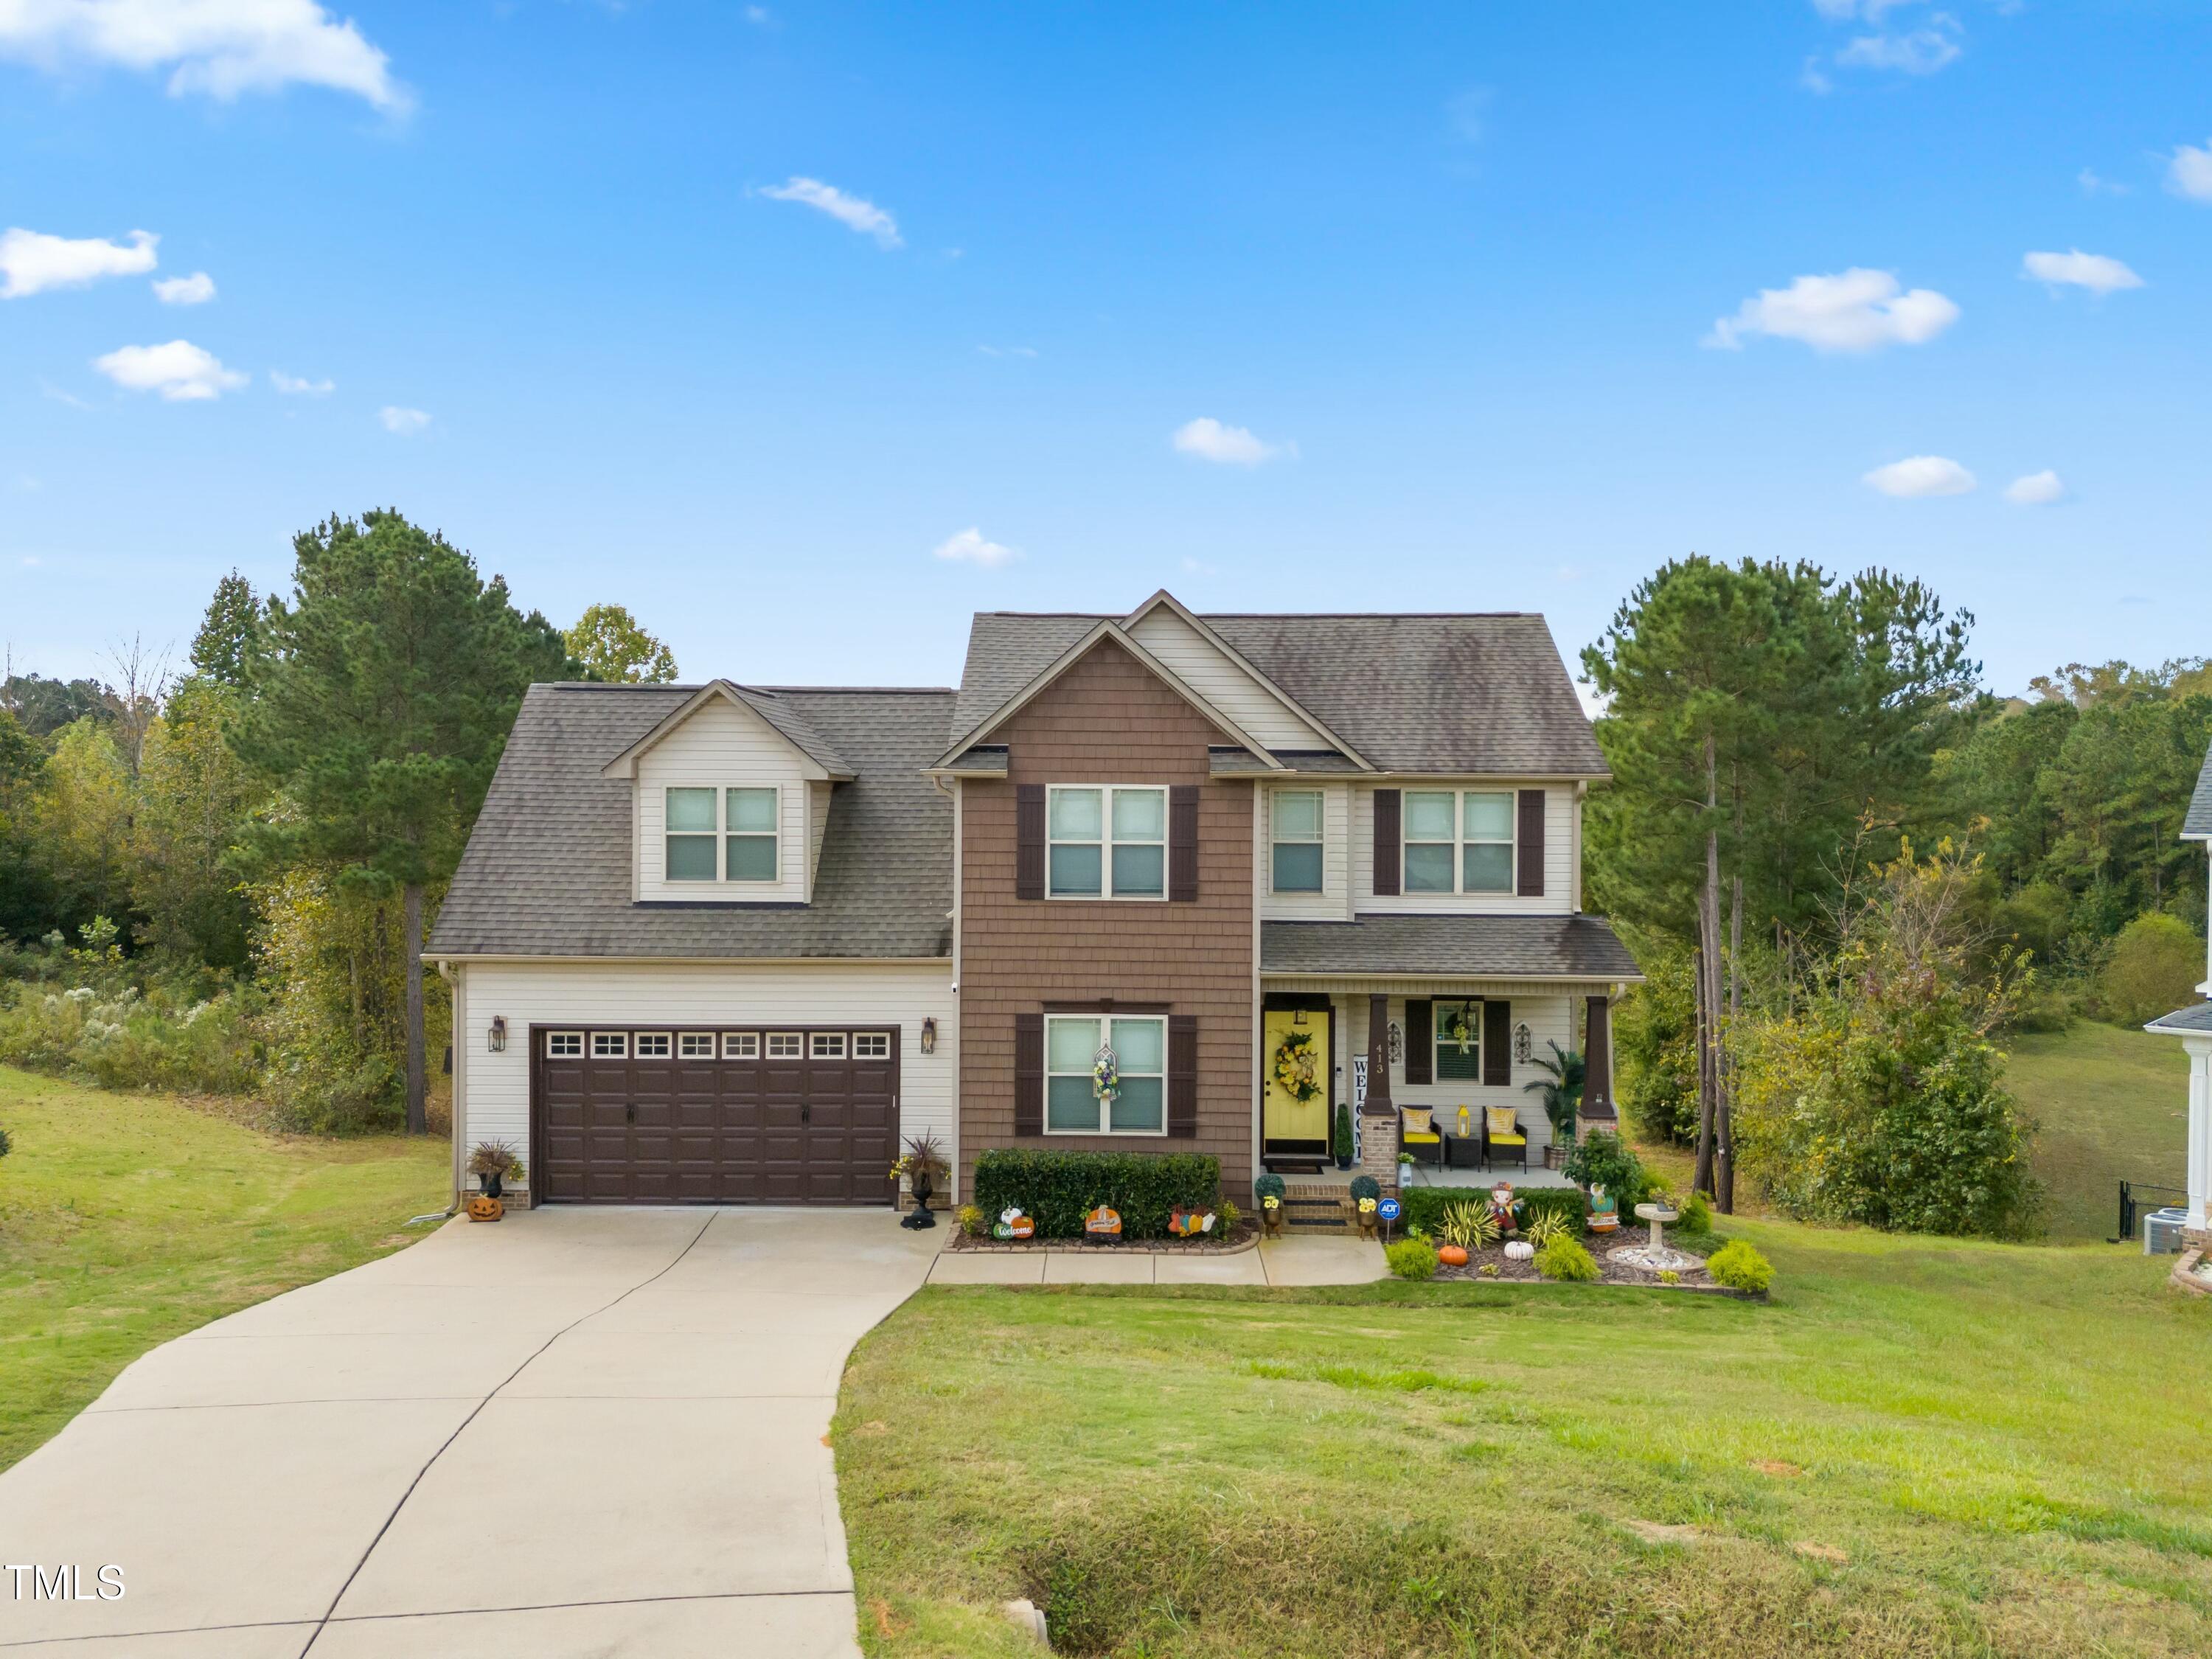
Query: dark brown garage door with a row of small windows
[[531, 1026, 898, 1203]]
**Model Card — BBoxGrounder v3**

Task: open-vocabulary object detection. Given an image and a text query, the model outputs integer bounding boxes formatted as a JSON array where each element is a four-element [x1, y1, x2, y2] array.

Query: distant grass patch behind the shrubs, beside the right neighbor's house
[[2006, 1020, 2190, 1239]]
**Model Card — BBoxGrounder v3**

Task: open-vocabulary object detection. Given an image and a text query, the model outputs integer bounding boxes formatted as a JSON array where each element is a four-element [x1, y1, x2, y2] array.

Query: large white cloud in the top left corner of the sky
[[0, 0, 407, 111]]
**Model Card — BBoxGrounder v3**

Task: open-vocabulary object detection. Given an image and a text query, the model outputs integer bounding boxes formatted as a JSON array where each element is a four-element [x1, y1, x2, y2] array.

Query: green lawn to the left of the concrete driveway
[[0, 1066, 451, 1469]]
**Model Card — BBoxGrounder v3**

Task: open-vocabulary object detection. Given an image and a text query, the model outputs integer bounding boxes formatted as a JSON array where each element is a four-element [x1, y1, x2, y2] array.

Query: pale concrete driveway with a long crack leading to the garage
[[0, 1208, 945, 1659]]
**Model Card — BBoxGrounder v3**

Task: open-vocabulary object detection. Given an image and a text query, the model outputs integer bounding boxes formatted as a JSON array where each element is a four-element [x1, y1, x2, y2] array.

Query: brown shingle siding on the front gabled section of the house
[[960, 641, 1252, 1192]]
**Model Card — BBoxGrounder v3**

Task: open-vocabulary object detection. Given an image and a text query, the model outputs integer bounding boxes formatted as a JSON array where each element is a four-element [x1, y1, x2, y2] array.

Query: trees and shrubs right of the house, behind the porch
[[1584, 557, 2212, 1232]]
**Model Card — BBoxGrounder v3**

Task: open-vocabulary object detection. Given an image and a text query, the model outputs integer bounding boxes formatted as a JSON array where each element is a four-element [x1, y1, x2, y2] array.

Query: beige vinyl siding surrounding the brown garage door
[[453, 960, 960, 1194]]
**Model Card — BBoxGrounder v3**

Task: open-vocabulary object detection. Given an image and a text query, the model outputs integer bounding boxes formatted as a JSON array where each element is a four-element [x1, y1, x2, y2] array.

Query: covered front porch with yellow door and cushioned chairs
[[1256, 916, 1641, 1197]]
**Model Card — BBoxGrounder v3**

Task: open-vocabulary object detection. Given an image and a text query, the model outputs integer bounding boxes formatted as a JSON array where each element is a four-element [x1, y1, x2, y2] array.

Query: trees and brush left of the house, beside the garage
[[0, 511, 675, 1133]]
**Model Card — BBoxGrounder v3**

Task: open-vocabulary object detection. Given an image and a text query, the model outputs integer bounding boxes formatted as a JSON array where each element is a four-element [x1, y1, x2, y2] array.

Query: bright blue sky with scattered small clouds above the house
[[0, 0, 2212, 690]]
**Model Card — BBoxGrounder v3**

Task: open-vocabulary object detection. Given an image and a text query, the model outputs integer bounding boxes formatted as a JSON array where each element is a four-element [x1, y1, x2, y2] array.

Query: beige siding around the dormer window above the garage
[[637, 699, 812, 905]]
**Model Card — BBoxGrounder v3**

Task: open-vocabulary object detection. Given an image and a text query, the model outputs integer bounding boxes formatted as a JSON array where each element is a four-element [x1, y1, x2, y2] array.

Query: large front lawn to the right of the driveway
[[834, 1221, 2212, 1659]]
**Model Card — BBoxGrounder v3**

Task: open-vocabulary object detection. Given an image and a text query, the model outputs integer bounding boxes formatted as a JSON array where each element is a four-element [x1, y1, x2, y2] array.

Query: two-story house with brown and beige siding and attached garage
[[425, 593, 1641, 1203]]
